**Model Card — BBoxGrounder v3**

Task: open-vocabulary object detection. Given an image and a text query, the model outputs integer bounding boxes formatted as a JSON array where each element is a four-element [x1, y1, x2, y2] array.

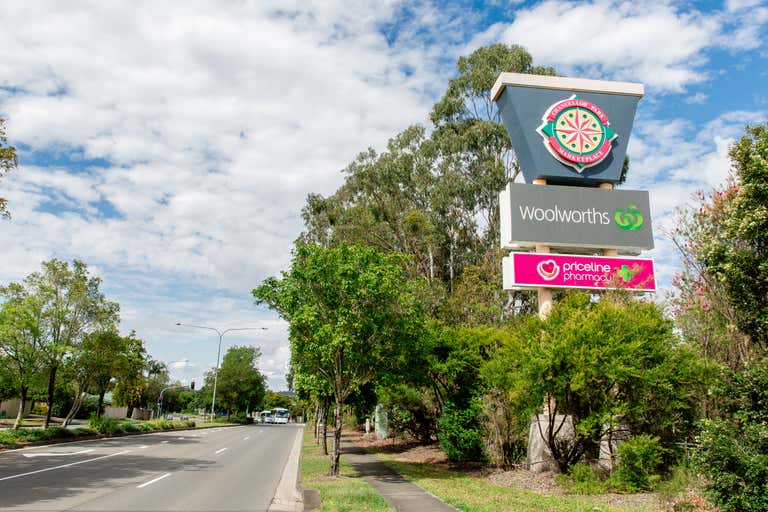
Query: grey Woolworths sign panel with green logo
[[499, 183, 653, 251]]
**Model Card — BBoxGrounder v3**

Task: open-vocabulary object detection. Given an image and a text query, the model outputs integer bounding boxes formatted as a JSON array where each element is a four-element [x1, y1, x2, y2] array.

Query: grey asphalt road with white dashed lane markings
[[0, 425, 299, 512]]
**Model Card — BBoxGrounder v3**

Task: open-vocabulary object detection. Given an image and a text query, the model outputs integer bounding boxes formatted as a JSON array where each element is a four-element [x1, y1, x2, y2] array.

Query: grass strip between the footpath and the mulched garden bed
[[377, 454, 658, 512]]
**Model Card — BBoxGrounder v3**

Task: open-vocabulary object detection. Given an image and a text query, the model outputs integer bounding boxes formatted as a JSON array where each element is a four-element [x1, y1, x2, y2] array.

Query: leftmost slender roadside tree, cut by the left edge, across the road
[[0, 292, 44, 429]]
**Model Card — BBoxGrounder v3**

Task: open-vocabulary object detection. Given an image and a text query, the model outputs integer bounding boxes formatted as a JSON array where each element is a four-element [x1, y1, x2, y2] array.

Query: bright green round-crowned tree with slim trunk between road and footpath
[[253, 243, 421, 475]]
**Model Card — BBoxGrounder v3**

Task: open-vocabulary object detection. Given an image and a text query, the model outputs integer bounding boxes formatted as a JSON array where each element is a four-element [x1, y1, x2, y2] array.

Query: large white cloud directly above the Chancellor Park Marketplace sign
[[471, 0, 722, 92]]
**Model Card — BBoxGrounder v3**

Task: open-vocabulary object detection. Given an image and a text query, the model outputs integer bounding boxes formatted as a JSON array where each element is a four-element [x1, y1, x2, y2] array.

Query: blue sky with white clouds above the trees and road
[[0, 0, 768, 390]]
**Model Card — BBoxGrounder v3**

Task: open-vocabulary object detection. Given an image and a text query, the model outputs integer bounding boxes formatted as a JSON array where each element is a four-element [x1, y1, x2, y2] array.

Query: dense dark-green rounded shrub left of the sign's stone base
[[438, 401, 485, 462]]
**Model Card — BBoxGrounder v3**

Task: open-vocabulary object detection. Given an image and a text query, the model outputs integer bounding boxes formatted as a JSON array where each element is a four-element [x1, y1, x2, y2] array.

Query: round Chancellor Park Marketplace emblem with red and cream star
[[537, 95, 617, 172]]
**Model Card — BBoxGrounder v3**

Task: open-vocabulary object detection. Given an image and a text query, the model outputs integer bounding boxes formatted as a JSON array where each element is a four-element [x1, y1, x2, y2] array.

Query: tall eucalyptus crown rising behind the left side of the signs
[[301, 45, 554, 303]]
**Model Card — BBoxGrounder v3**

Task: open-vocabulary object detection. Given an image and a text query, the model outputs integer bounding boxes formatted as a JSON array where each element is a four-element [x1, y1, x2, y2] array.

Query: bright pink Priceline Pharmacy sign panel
[[504, 252, 656, 292]]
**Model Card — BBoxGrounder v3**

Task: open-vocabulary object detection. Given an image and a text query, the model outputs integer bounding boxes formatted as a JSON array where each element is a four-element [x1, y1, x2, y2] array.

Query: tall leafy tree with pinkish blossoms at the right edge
[[672, 125, 768, 369]]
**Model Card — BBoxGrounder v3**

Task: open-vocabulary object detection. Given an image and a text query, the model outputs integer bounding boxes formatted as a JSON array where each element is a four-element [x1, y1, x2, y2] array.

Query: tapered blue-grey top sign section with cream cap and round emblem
[[491, 73, 643, 185]]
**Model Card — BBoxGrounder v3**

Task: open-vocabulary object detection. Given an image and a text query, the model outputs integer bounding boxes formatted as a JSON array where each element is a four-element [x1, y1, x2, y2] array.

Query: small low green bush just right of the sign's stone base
[[611, 434, 664, 492]]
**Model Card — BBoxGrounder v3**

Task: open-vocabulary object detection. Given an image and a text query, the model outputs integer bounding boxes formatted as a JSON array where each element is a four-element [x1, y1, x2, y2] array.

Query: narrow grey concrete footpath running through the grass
[[341, 438, 458, 512]]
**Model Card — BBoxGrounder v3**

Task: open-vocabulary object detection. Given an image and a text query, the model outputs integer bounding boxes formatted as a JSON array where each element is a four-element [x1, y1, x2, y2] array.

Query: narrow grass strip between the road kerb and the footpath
[[301, 429, 390, 512]]
